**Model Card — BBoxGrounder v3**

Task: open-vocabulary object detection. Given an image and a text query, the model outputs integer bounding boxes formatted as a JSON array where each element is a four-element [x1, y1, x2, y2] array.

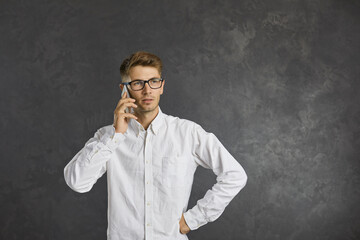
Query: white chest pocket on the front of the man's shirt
[[162, 156, 187, 188]]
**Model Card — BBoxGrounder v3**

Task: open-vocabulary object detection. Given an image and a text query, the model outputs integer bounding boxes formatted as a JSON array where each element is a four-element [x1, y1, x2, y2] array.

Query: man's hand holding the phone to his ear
[[114, 92, 137, 133]]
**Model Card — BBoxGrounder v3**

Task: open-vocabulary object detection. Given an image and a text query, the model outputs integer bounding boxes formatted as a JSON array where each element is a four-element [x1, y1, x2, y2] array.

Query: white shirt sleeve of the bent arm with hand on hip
[[184, 124, 247, 230]]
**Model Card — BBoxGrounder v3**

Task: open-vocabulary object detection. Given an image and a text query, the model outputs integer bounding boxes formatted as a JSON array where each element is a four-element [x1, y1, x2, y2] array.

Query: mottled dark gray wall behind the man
[[0, 0, 360, 240]]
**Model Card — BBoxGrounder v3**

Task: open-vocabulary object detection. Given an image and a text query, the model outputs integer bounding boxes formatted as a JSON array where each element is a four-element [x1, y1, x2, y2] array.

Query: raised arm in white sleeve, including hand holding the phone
[[64, 90, 137, 193]]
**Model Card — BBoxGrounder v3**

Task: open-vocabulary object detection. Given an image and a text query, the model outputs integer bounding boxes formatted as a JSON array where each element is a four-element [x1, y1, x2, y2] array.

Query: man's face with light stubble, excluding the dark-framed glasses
[[129, 66, 165, 113]]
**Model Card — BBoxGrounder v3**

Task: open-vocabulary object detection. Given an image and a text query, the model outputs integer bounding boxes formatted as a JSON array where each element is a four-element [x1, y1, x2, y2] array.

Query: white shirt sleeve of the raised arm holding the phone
[[64, 126, 125, 193]]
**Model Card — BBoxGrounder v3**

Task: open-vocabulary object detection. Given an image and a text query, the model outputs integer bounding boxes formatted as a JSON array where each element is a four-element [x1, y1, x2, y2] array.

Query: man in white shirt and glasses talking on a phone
[[64, 52, 247, 240]]
